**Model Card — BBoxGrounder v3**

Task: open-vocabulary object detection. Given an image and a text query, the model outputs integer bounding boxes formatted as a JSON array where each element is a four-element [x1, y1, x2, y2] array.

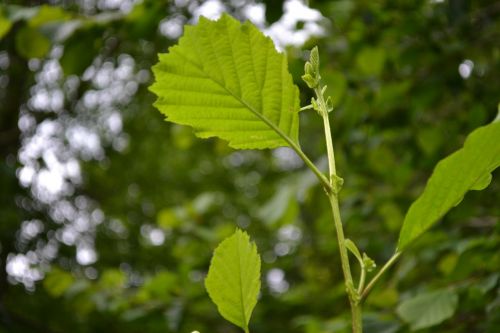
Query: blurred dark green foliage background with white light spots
[[0, 0, 500, 333]]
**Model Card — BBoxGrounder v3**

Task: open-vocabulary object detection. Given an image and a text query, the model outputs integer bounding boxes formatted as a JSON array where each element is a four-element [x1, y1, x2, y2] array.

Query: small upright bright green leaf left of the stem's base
[[205, 229, 260, 331]]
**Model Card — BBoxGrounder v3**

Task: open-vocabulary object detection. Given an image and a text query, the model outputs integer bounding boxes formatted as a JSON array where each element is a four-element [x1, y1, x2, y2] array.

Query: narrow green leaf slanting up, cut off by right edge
[[398, 122, 500, 251]]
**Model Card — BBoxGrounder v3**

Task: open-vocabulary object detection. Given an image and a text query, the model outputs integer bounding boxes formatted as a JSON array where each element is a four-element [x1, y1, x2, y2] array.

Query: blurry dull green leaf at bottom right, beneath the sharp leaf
[[396, 290, 458, 331]]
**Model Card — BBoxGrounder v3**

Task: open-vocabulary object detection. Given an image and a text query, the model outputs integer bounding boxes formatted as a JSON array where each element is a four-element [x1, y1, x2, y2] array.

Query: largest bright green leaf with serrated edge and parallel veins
[[150, 14, 299, 149]]
